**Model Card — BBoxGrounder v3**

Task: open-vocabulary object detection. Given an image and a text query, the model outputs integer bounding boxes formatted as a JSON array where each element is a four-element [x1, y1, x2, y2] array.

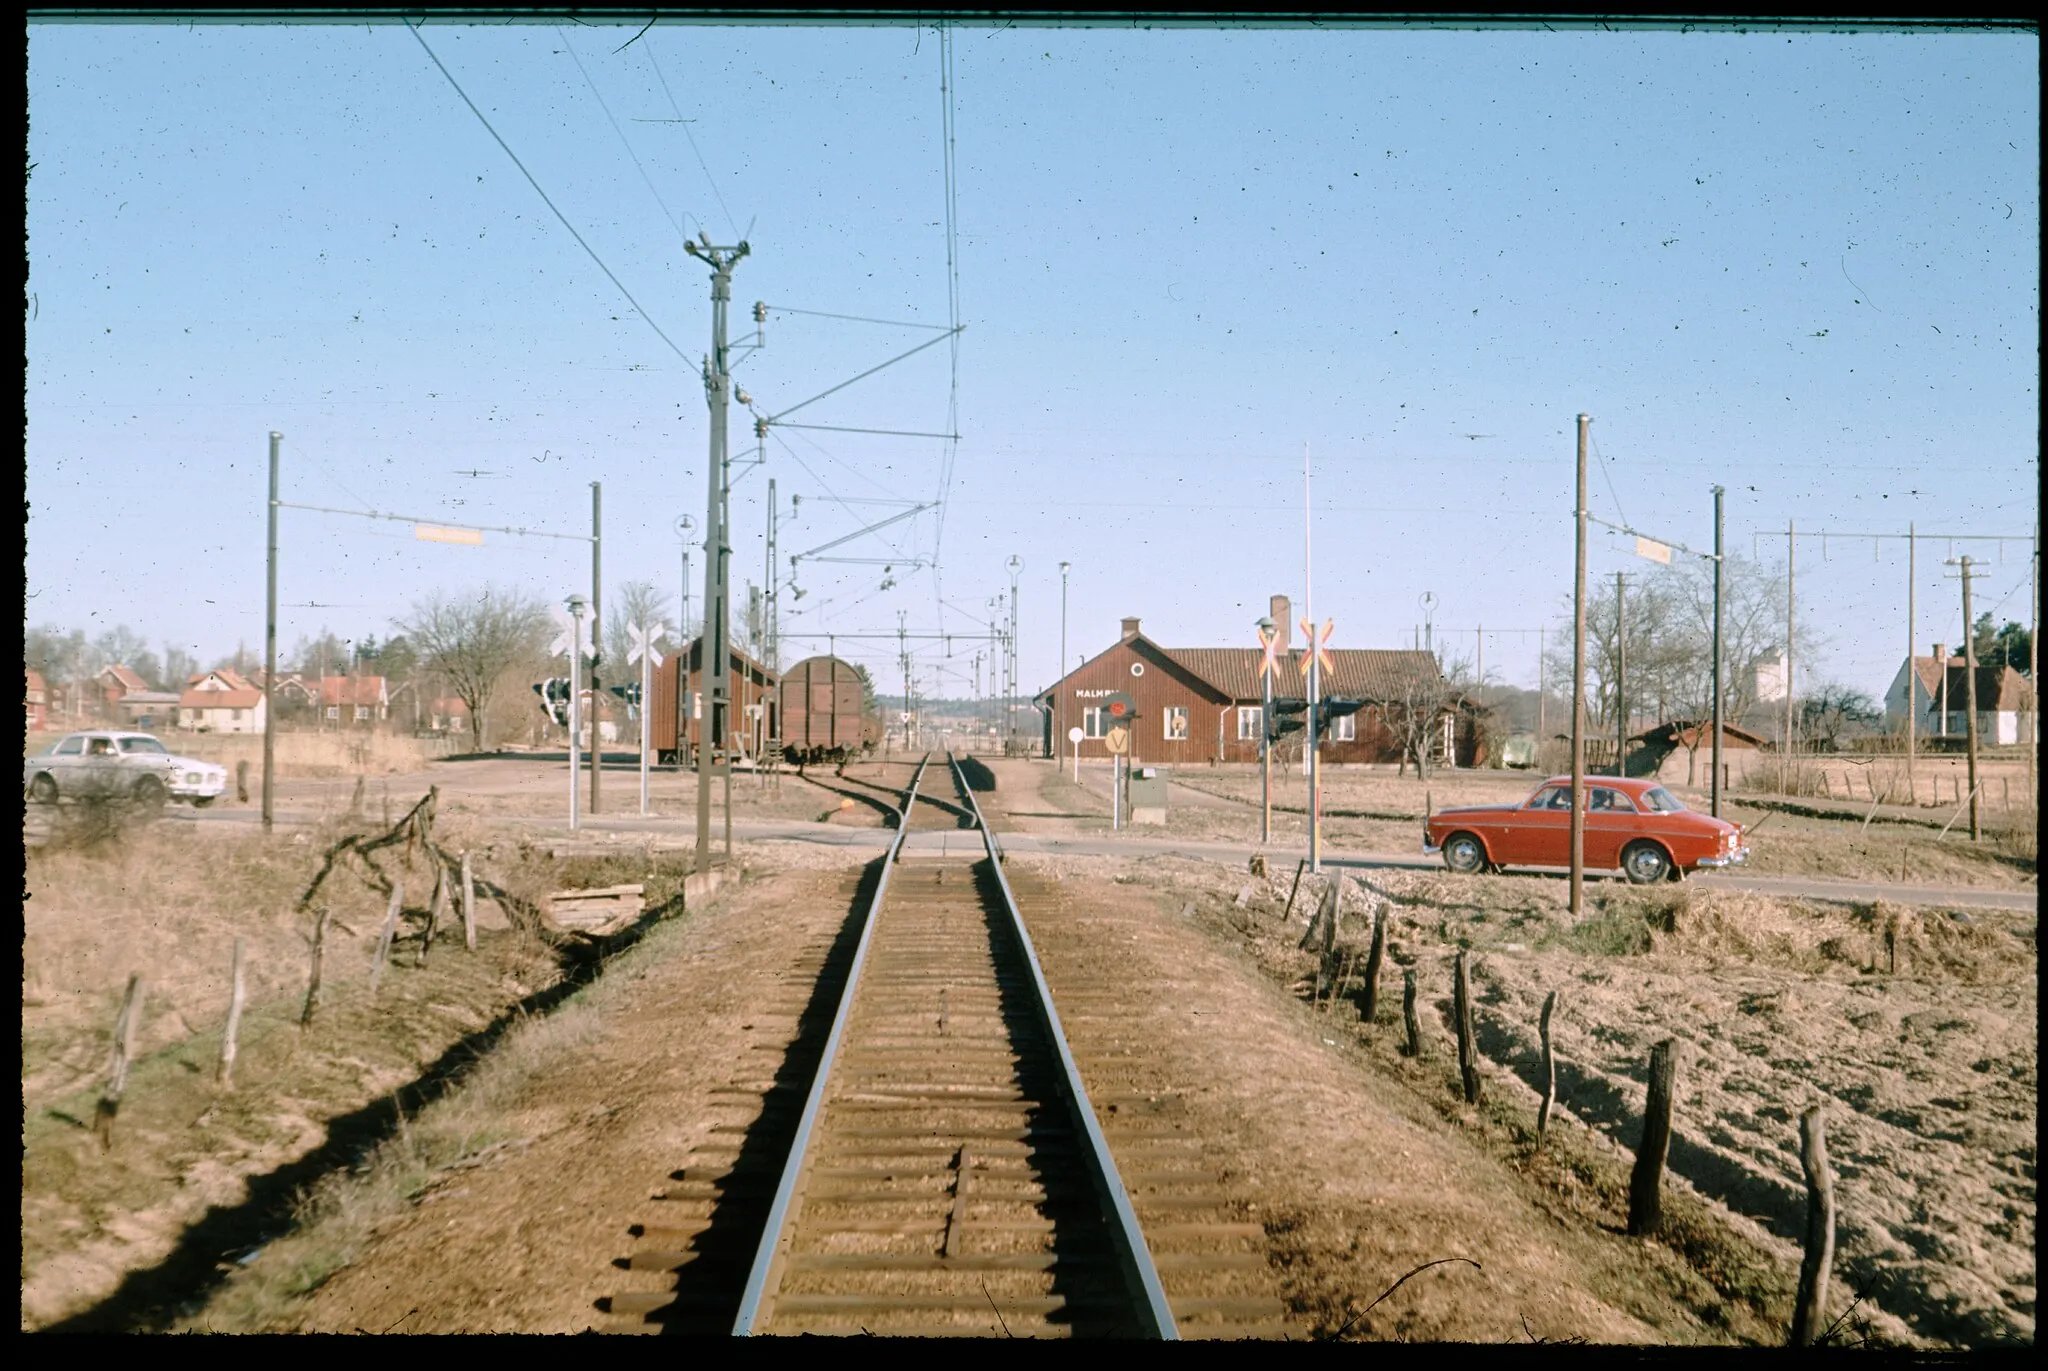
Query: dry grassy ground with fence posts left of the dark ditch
[[23, 807, 720, 1328]]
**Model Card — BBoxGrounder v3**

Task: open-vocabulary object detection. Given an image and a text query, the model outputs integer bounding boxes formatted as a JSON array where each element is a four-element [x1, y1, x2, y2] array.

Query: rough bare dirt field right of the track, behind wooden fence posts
[[1155, 869, 2038, 1346]]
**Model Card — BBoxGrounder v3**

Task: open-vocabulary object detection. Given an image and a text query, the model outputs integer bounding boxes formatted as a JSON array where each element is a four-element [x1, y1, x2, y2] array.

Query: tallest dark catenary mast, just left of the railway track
[[678, 234, 748, 871]]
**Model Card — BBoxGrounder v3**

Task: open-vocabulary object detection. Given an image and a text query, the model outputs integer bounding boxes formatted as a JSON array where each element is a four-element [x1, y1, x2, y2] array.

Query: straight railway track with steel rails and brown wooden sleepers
[[608, 758, 1280, 1338]]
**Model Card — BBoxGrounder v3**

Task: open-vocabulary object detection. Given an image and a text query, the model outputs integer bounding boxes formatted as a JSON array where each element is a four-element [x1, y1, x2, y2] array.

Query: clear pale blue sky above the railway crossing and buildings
[[27, 25, 2040, 693]]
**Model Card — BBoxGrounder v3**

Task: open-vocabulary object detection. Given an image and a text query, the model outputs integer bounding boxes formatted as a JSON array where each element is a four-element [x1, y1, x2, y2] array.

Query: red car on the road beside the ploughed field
[[1421, 777, 1749, 885]]
